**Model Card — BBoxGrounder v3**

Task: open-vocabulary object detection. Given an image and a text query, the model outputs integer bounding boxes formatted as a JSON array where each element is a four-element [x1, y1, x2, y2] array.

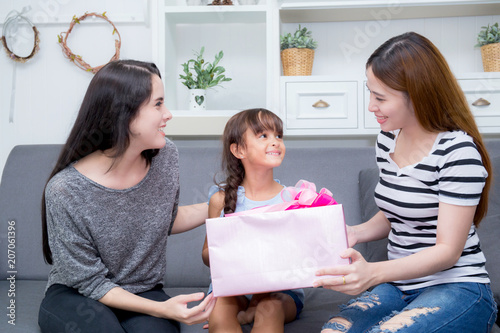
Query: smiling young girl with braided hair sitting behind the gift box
[[202, 109, 304, 332]]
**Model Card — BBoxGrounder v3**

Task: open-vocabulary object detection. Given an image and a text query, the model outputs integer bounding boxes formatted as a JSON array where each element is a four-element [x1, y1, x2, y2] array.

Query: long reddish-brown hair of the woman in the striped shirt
[[366, 32, 493, 226]]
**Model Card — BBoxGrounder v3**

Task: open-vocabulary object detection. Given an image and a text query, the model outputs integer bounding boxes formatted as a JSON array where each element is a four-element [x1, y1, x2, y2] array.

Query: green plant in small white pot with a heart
[[179, 47, 232, 111]]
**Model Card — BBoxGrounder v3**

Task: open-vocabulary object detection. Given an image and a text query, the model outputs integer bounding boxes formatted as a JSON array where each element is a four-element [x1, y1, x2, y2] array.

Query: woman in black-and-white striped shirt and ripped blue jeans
[[315, 32, 497, 333]]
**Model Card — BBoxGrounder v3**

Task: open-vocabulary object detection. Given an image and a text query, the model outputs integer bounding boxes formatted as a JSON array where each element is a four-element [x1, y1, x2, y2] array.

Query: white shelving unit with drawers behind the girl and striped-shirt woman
[[152, 0, 500, 136]]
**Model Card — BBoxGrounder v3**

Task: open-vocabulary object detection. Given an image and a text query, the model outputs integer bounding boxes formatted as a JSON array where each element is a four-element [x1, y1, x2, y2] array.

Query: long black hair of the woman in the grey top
[[42, 60, 160, 264]]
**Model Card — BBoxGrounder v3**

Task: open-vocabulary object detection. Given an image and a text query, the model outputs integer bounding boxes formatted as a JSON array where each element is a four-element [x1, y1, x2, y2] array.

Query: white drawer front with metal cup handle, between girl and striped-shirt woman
[[285, 81, 358, 129]]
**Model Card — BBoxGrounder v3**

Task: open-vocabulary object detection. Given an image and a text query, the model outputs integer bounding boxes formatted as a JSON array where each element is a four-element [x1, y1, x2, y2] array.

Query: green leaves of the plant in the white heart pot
[[179, 47, 232, 89]]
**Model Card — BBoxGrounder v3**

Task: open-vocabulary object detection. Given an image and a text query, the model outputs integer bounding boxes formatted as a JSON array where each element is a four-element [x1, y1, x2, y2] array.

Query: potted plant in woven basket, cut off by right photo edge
[[476, 22, 500, 72]]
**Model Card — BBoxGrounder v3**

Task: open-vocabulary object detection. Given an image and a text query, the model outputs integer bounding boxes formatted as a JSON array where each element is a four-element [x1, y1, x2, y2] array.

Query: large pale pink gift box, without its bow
[[206, 205, 349, 297]]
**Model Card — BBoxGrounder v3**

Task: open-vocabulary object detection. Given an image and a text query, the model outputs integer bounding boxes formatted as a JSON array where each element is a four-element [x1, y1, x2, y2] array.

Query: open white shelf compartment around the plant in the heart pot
[[153, 0, 273, 136]]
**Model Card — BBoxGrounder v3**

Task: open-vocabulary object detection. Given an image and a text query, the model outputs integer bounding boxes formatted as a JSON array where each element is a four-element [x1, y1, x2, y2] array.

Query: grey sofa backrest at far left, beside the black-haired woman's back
[[0, 145, 61, 280]]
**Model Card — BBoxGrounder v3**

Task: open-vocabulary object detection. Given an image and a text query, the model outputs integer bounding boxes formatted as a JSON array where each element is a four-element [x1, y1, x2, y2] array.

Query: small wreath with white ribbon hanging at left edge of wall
[[2, 6, 40, 123]]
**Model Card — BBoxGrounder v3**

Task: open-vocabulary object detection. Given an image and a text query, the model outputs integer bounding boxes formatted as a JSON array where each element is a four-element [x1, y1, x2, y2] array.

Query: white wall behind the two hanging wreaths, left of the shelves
[[0, 0, 152, 174]]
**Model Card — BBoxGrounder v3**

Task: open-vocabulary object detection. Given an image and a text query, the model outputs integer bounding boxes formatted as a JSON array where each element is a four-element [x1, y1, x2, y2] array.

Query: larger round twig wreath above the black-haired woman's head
[[57, 12, 122, 74]]
